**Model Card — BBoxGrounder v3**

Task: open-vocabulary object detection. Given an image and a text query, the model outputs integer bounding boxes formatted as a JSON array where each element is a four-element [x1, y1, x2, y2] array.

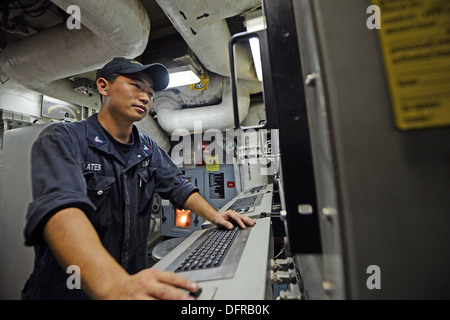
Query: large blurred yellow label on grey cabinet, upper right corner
[[372, 0, 450, 130]]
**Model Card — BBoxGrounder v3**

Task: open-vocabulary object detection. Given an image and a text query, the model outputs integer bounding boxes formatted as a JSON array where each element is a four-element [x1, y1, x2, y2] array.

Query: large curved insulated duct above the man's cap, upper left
[[0, 0, 150, 107]]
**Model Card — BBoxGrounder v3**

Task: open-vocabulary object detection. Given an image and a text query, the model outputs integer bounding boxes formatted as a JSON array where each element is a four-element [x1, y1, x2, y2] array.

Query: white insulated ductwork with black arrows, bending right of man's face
[[153, 0, 261, 134]]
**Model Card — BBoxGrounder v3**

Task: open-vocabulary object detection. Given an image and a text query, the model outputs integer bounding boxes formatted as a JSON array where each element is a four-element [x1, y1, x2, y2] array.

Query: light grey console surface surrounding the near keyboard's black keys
[[153, 218, 273, 300]]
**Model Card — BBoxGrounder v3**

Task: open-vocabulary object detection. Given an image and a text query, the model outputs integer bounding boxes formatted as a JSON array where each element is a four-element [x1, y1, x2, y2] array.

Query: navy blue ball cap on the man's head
[[97, 57, 169, 91]]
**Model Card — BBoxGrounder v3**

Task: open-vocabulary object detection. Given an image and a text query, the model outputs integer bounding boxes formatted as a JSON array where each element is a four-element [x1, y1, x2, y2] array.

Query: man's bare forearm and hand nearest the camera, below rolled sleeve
[[44, 208, 198, 300]]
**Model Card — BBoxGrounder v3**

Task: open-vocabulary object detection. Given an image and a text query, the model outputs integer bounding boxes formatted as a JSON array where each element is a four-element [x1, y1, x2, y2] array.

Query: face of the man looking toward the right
[[106, 72, 155, 122]]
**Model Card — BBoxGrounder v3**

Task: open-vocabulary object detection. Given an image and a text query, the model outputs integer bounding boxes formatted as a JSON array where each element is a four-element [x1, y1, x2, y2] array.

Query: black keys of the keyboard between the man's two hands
[[175, 228, 240, 272]]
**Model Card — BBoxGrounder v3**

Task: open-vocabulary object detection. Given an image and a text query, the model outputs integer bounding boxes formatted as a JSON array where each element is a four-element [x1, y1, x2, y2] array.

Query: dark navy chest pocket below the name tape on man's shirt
[[84, 173, 116, 228]]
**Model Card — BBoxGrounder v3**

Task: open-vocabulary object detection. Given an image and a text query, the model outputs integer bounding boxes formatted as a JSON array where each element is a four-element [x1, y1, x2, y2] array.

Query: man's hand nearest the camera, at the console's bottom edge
[[107, 269, 199, 300]]
